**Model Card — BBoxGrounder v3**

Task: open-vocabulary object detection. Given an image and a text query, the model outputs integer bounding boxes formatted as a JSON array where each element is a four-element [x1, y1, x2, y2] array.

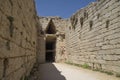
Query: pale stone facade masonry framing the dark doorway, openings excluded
[[38, 16, 68, 62]]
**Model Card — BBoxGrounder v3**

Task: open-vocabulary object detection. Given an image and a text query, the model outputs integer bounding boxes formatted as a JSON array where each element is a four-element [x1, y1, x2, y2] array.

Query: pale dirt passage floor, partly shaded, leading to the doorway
[[29, 63, 120, 80]]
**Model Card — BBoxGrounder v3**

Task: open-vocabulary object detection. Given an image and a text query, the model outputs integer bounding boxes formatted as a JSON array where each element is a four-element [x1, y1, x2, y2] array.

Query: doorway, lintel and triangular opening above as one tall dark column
[[46, 19, 56, 62]]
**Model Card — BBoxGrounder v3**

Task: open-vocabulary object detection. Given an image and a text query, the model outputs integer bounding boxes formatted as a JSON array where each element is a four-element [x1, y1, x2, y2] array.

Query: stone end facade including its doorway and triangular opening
[[37, 17, 68, 63]]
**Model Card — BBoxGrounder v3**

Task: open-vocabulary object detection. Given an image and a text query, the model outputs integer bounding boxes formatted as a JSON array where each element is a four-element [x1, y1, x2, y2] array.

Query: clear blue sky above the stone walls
[[35, 0, 96, 18]]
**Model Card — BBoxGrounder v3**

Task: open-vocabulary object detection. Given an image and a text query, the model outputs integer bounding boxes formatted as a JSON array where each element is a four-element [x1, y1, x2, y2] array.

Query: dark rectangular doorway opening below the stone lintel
[[46, 41, 55, 62]]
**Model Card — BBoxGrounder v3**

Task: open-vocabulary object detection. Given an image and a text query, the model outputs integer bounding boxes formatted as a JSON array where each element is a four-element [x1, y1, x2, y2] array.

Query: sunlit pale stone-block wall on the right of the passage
[[65, 0, 120, 74]]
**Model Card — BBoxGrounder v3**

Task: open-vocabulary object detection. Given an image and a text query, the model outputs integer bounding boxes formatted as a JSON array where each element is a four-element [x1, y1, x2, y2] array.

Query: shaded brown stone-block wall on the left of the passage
[[0, 0, 38, 80]]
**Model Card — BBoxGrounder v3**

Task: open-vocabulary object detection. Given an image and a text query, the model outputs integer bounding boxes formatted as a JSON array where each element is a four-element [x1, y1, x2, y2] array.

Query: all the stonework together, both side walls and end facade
[[0, 0, 120, 80]]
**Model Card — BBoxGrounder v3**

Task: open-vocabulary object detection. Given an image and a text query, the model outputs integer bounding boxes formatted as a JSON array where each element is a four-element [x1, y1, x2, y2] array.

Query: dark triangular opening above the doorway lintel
[[45, 19, 56, 34]]
